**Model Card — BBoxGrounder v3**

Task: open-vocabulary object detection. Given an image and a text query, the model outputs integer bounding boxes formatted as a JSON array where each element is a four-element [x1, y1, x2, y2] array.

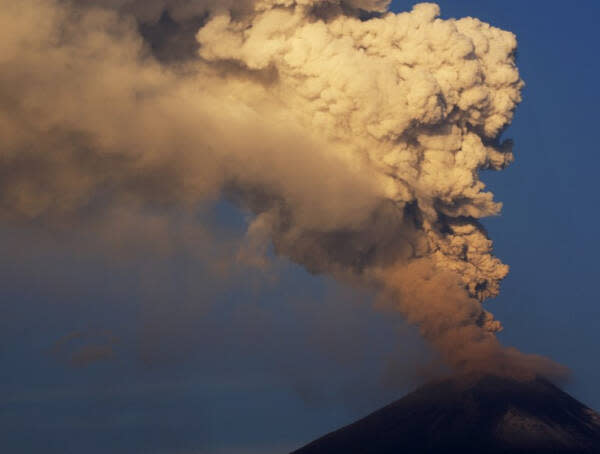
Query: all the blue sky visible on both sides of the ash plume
[[0, 0, 600, 454]]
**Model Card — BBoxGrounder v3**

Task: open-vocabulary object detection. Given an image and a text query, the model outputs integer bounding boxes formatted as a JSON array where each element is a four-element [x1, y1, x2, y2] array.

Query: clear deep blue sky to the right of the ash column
[[420, 0, 600, 409]]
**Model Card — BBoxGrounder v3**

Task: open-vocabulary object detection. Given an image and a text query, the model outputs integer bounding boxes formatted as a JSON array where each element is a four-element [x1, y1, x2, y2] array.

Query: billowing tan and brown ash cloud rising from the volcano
[[0, 0, 560, 380]]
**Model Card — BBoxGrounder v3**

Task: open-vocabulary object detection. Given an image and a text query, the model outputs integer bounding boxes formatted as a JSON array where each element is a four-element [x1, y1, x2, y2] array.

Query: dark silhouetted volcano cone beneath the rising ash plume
[[293, 376, 600, 454]]
